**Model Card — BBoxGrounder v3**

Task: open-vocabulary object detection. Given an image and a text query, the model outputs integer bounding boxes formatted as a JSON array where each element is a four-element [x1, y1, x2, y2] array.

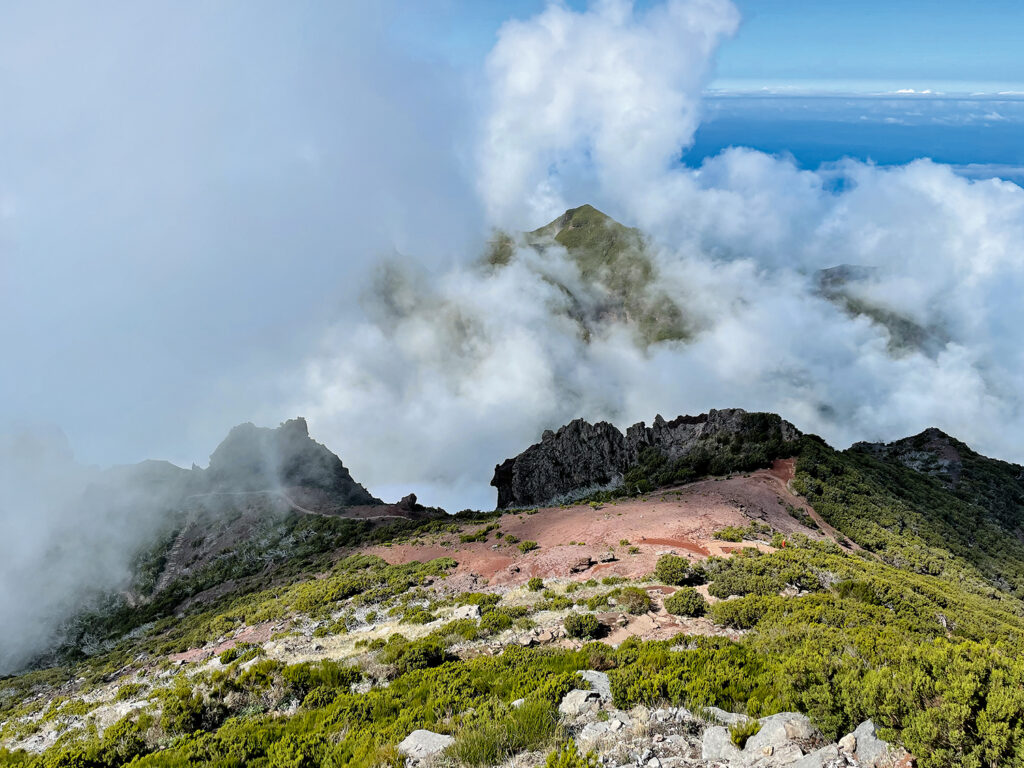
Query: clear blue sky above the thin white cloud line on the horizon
[[395, 0, 1024, 90]]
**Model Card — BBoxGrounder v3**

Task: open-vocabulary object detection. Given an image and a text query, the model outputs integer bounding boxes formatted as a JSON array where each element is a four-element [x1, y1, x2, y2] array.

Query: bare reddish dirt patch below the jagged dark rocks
[[368, 460, 834, 585]]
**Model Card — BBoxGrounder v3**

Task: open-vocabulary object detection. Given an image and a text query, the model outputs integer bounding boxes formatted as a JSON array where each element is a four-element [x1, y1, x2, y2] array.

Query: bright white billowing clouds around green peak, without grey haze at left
[[297, 0, 1024, 518]]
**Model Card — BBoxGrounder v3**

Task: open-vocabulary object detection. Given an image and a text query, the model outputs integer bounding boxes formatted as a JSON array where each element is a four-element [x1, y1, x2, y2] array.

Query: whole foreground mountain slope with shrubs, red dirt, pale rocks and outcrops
[[9, 411, 1024, 768]]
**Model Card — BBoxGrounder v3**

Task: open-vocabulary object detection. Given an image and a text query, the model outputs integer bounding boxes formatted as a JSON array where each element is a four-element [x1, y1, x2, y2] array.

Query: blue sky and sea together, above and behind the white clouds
[[391, 0, 1024, 176]]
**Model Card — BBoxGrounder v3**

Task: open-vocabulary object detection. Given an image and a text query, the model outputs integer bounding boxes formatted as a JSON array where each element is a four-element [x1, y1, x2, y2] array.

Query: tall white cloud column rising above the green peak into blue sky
[[479, 0, 739, 228]]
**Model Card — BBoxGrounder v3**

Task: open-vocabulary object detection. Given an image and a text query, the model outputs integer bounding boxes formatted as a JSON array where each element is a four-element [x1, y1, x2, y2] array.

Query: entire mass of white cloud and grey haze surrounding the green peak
[[6, 0, 1024, 669]]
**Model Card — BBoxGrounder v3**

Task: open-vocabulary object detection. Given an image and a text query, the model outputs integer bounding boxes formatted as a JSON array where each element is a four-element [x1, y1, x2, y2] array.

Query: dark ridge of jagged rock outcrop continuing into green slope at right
[[492, 409, 1024, 597]]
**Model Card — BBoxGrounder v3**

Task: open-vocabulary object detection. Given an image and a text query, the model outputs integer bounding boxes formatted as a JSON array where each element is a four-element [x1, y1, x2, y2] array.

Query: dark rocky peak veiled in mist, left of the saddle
[[205, 417, 381, 506]]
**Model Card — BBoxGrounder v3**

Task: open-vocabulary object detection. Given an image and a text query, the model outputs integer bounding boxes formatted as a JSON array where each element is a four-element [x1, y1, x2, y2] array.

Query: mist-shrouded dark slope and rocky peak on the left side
[[0, 419, 385, 674]]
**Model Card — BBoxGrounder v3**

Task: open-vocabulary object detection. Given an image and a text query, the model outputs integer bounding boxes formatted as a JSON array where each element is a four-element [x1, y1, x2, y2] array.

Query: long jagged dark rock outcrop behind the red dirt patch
[[490, 409, 801, 509]]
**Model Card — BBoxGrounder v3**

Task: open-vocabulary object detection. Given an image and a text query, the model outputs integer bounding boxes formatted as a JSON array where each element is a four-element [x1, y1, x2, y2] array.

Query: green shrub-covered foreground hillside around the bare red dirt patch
[[8, 421, 1024, 768]]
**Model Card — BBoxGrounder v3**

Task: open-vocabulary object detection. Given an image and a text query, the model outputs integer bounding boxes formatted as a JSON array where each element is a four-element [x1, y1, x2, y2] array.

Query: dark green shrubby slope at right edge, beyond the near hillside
[[794, 430, 1024, 597]]
